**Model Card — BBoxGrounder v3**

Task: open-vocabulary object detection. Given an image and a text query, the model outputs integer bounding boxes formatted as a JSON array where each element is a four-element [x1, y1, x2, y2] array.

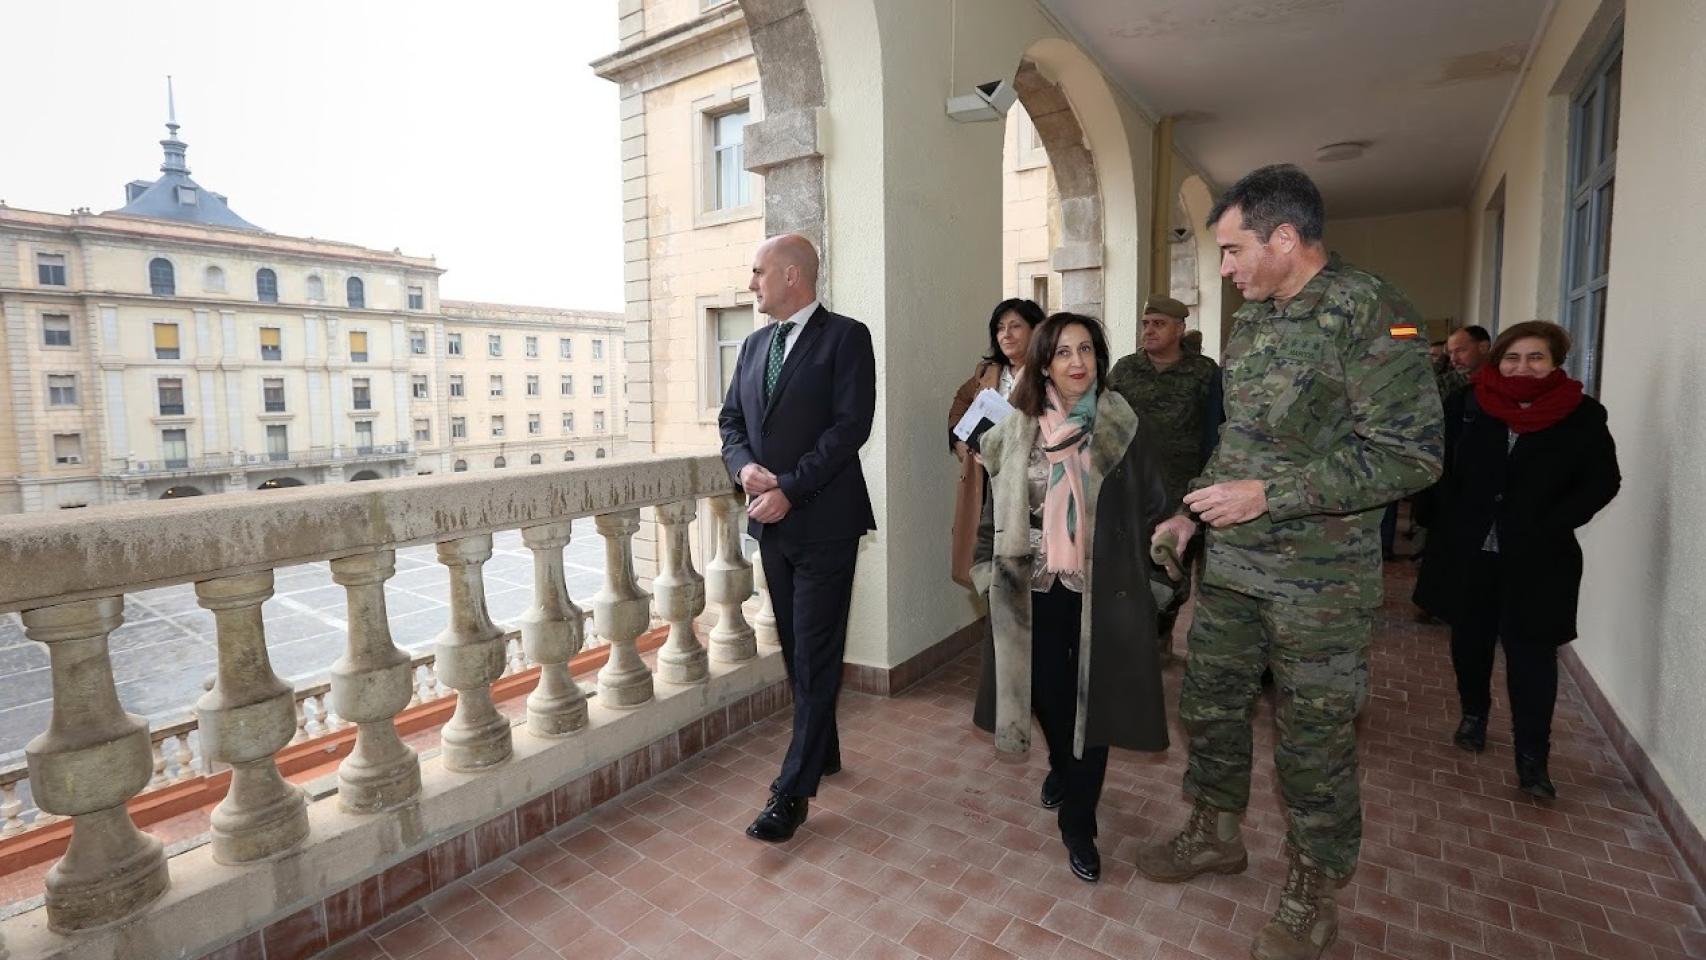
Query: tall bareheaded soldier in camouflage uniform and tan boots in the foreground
[[1138, 165, 1442, 960]]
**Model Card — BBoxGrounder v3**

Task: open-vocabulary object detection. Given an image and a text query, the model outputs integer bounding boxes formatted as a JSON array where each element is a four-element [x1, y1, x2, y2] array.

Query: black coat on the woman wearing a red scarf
[[1414, 389, 1622, 645]]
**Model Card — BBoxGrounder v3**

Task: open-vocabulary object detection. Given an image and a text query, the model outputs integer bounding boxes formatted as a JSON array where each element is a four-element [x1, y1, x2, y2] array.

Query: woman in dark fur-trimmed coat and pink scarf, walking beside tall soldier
[[972, 314, 1167, 882]]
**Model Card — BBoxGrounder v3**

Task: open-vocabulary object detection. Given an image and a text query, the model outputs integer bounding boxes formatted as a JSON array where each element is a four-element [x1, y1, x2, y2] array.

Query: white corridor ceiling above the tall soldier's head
[[1041, 0, 1547, 218]]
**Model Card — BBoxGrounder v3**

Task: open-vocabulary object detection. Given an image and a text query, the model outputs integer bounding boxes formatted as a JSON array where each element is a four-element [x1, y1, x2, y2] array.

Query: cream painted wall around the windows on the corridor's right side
[[1464, 0, 1706, 825]]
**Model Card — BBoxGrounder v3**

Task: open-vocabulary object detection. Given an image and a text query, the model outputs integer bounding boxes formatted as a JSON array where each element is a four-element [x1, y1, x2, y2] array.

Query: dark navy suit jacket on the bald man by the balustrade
[[717, 307, 877, 544]]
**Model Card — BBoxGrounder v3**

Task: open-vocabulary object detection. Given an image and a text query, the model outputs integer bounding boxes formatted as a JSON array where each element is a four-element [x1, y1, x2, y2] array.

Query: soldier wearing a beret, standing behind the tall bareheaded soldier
[[1107, 297, 1221, 667]]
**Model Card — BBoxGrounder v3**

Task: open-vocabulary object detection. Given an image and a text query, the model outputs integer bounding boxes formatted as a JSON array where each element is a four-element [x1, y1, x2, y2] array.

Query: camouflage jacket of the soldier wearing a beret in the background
[[1107, 350, 1220, 510]]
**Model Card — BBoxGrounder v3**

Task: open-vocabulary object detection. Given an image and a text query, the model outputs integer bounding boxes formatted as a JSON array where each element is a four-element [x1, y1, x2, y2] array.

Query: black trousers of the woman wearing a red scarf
[[1452, 551, 1558, 757]]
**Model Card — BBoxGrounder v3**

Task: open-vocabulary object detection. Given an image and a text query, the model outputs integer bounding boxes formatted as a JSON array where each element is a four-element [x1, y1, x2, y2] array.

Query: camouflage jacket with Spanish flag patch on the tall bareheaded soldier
[[1191, 254, 1443, 607]]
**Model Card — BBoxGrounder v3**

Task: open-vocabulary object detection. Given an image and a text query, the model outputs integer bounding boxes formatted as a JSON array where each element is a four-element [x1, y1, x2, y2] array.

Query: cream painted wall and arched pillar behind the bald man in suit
[[809, 0, 1150, 667]]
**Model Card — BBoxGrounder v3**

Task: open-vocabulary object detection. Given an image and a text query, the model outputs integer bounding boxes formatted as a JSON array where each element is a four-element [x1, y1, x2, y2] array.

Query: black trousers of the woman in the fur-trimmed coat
[[1030, 583, 1107, 841]]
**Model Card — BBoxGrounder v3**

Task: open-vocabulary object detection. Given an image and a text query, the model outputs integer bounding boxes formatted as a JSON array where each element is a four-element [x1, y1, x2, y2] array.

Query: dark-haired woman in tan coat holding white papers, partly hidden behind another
[[949, 300, 1042, 587]]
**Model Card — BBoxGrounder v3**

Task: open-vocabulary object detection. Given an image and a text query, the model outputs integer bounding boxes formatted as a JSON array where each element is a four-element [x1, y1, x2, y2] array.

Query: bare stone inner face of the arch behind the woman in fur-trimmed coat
[[1013, 56, 1104, 317]]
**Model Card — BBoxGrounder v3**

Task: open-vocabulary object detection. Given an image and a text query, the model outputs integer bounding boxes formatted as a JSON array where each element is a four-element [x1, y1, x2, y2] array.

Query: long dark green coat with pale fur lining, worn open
[[971, 390, 1169, 757]]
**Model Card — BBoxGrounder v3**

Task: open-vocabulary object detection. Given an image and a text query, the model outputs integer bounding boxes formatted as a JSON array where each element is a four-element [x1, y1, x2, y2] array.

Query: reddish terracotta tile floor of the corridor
[[324, 568, 1706, 960]]
